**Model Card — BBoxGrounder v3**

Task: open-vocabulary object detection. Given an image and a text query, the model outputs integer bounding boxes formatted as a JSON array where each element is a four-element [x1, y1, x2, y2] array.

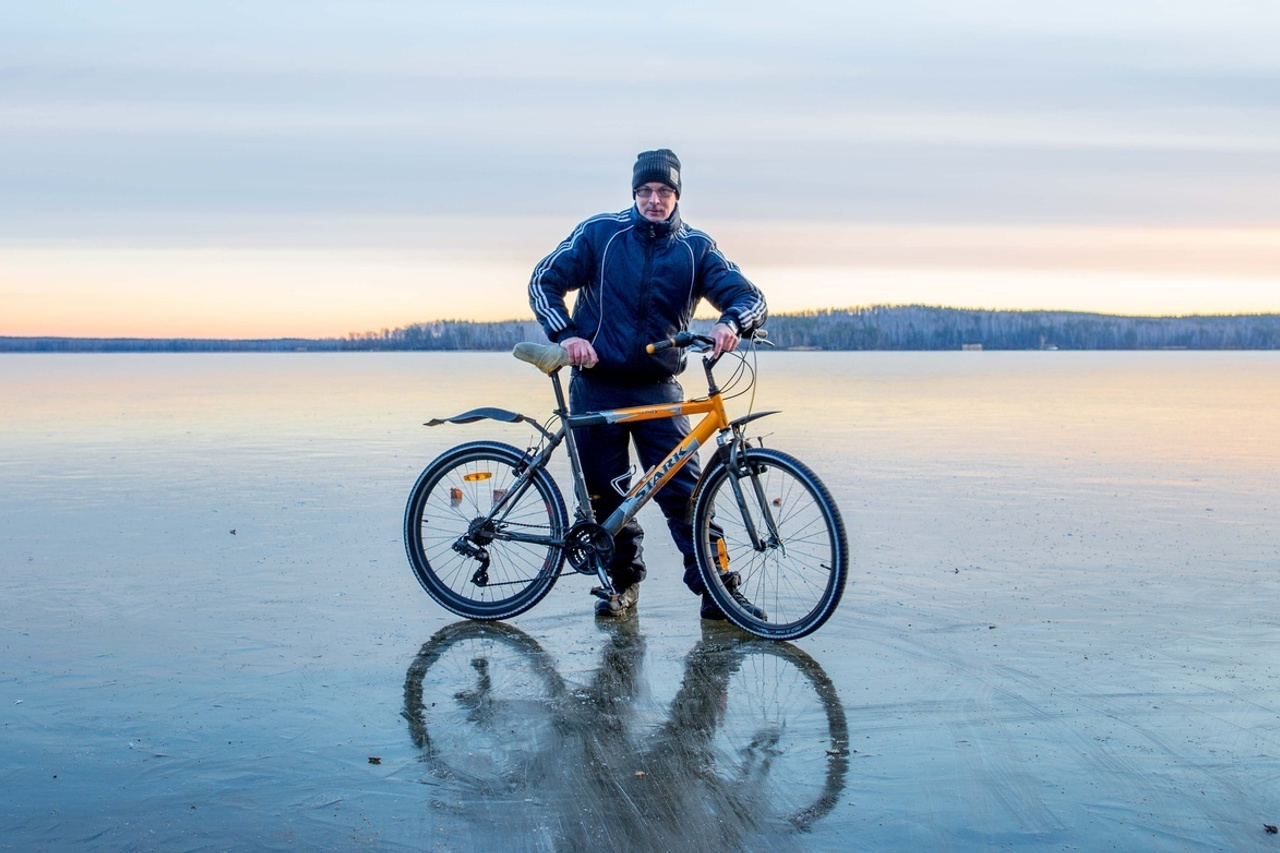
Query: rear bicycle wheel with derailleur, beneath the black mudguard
[[404, 442, 568, 621]]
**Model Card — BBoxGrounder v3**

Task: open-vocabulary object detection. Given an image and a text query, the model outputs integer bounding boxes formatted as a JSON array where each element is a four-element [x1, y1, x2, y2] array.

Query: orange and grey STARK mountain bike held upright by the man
[[404, 332, 849, 639]]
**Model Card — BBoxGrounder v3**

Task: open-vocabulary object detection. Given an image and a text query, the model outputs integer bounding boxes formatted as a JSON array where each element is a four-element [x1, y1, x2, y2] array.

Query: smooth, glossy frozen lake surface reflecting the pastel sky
[[0, 352, 1280, 850]]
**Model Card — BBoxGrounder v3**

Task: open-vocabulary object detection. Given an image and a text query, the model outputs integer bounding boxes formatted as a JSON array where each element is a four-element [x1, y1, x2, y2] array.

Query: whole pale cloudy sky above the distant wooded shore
[[0, 0, 1280, 337]]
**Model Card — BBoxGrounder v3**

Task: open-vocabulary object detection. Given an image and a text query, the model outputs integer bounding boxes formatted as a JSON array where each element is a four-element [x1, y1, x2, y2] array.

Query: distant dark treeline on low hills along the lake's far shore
[[10, 305, 1280, 352]]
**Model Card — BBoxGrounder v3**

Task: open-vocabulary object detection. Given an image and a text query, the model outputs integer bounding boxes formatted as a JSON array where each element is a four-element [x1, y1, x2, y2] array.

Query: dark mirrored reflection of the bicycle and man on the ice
[[404, 619, 849, 835]]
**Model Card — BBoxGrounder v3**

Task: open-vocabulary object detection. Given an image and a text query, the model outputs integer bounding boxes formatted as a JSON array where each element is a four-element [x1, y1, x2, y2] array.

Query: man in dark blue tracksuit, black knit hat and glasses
[[529, 149, 767, 619]]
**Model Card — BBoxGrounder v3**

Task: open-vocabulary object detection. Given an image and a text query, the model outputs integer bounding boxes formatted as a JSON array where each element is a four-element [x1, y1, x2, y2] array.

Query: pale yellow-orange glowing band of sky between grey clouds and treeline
[[0, 220, 1280, 338]]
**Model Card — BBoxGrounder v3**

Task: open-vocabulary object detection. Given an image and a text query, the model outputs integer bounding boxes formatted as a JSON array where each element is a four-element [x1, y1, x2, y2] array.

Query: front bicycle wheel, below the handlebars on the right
[[694, 447, 849, 640]]
